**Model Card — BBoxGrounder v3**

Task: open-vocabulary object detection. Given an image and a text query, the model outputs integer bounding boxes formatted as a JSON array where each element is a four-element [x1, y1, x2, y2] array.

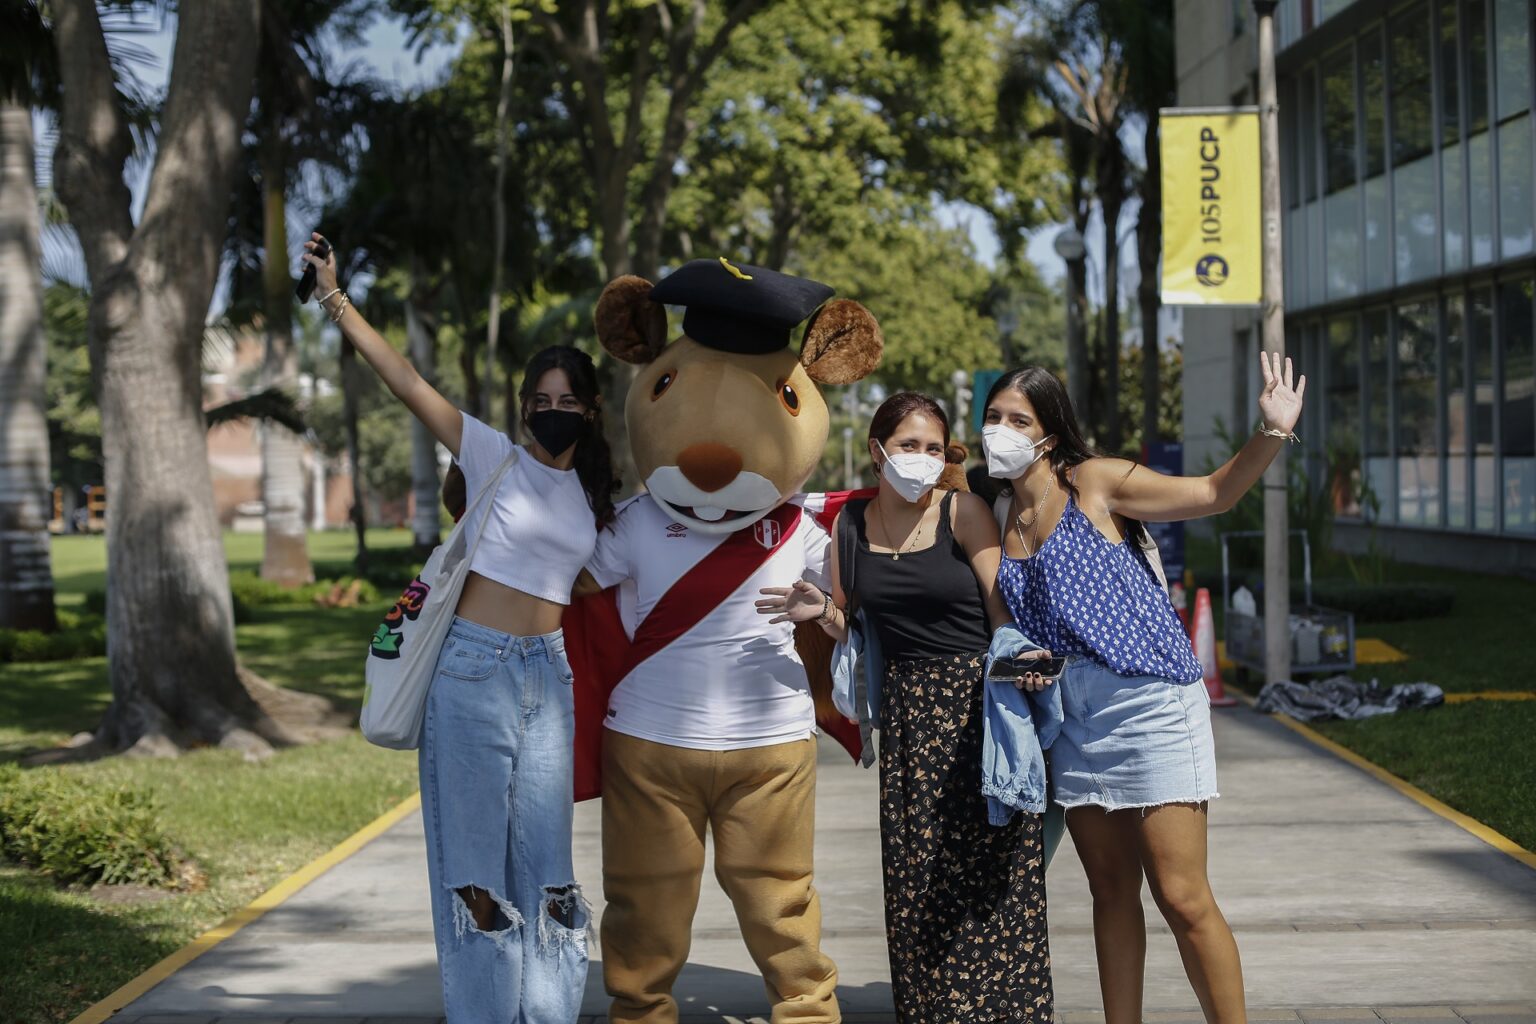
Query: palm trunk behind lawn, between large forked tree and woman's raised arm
[[261, 138, 315, 586]]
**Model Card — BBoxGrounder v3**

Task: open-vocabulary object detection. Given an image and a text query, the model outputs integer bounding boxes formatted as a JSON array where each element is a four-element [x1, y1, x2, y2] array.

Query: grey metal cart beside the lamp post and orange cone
[[1221, 530, 1355, 676]]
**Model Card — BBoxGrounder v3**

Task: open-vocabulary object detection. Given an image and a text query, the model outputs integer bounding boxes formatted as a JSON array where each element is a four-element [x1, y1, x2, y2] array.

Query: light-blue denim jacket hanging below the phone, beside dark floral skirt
[[982, 623, 1061, 824]]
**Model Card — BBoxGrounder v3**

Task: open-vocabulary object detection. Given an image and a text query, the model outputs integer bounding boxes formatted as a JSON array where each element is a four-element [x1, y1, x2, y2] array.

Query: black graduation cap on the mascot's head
[[651, 256, 833, 356]]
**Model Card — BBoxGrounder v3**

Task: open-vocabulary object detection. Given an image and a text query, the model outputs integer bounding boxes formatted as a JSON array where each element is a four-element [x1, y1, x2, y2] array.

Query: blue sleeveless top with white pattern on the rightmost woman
[[997, 496, 1201, 683]]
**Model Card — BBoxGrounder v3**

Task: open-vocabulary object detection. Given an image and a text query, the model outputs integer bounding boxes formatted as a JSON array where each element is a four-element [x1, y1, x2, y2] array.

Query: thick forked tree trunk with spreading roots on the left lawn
[[54, 0, 339, 757]]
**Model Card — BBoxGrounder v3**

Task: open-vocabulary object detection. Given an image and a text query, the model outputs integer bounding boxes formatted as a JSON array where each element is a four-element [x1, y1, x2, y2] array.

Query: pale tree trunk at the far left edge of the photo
[[0, 100, 58, 629]]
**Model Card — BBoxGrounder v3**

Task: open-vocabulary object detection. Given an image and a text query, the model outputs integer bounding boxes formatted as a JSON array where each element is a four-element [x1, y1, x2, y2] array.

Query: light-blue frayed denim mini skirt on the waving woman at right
[[1049, 657, 1220, 811]]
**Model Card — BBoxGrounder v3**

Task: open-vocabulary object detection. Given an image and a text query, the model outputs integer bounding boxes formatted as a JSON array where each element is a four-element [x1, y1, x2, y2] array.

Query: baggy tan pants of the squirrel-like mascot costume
[[601, 729, 842, 1024]]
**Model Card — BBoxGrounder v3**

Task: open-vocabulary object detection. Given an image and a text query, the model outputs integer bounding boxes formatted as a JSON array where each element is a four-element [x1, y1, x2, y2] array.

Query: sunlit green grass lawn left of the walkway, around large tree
[[0, 531, 416, 1024]]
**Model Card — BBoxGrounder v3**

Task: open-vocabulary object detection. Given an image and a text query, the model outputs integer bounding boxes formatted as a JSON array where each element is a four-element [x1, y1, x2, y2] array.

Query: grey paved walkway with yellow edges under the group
[[112, 708, 1536, 1024]]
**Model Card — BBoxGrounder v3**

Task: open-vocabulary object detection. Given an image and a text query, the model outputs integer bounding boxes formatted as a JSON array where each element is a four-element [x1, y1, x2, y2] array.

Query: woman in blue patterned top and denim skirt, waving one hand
[[982, 355, 1306, 1024]]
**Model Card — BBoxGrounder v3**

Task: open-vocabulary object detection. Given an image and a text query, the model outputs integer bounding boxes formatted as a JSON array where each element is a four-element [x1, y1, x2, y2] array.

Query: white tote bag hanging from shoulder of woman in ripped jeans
[[358, 445, 519, 751]]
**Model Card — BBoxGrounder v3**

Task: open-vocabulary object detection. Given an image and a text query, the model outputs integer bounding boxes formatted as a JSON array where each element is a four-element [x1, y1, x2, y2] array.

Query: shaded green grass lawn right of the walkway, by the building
[[1190, 542, 1536, 849]]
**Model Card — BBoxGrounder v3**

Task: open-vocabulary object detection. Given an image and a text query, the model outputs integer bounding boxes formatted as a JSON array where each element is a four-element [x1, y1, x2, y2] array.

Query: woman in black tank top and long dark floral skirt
[[759, 393, 1054, 1024]]
